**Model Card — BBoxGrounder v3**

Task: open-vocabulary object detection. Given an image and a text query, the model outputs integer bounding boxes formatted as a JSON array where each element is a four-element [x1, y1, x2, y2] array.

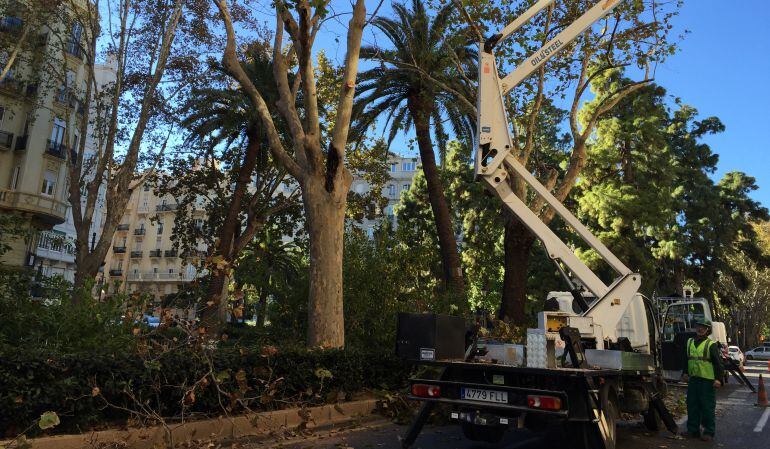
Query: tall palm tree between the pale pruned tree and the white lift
[[353, 0, 476, 294]]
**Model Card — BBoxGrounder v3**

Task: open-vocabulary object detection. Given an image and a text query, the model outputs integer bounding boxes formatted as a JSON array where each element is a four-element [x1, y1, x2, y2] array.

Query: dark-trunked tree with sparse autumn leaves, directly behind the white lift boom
[[444, 0, 679, 324]]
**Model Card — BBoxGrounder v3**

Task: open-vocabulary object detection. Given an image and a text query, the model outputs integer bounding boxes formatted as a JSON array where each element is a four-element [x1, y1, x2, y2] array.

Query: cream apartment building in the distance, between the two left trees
[[97, 175, 207, 301]]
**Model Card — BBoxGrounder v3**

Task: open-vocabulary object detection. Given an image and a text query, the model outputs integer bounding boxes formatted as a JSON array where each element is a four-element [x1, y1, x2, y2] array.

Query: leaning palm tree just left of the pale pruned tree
[[177, 46, 293, 332]]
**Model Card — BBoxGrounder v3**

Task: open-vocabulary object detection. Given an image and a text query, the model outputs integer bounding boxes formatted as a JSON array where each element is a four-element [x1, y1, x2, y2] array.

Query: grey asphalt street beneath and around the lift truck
[[260, 361, 770, 449]]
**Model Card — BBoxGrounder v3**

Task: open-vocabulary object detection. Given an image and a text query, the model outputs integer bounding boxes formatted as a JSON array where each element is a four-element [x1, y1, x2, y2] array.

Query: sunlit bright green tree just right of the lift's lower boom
[[574, 79, 679, 294]]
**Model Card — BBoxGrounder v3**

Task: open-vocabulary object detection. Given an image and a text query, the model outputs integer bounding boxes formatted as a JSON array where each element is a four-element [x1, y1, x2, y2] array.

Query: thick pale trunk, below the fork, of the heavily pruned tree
[[302, 177, 350, 348]]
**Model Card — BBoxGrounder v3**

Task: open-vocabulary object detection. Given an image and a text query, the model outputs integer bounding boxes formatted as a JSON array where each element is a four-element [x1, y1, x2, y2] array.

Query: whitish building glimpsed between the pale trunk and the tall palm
[[350, 153, 420, 237]]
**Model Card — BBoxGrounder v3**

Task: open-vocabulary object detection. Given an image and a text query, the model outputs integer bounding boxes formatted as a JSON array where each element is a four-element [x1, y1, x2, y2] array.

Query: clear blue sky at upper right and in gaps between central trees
[[317, 0, 770, 206]]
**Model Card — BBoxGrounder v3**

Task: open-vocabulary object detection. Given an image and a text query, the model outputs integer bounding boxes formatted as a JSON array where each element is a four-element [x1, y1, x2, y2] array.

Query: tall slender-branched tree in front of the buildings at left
[[50, 0, 191, 297]]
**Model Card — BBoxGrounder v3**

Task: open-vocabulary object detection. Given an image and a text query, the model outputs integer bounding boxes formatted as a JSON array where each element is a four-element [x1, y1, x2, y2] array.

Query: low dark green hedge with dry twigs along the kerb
[[0, 347, 408, 437]]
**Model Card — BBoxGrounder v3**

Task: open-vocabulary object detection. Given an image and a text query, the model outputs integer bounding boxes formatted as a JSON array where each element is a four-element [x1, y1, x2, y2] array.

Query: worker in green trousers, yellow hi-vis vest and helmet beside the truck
[[682, 318, 724, 441]]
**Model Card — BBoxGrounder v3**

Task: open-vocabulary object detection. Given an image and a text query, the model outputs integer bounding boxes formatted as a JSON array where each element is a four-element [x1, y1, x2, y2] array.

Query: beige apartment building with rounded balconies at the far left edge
[[0, 1, 93, 266]]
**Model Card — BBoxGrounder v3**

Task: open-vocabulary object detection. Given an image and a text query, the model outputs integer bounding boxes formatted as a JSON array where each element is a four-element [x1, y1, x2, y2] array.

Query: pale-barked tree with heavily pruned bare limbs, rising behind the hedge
[[213, 0, 366, 347]]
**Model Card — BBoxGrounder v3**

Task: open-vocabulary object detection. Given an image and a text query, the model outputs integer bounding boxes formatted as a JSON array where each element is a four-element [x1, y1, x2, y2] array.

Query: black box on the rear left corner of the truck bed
[[396, 312, 466, 361]]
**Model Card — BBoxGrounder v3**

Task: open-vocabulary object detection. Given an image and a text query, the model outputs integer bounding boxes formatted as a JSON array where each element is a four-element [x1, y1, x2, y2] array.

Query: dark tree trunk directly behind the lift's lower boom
[[497, 216, 535, 325]]
